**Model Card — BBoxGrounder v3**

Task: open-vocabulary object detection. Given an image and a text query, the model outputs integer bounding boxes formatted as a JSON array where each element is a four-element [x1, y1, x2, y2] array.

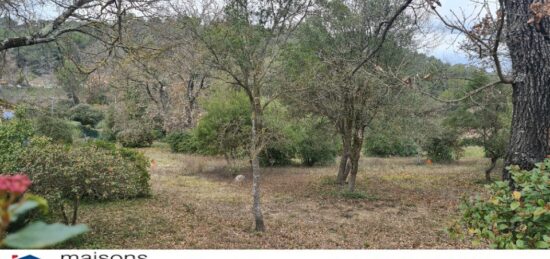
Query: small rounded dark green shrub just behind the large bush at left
[[34, 116, 74, 144]]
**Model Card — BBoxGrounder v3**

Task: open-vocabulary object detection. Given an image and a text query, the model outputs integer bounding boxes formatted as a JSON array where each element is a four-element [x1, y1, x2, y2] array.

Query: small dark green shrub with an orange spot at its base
[[424, 134, 462, 163]]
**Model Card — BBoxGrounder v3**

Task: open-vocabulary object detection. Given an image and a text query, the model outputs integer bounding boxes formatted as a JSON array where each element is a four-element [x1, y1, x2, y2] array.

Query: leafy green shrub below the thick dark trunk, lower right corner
[[450, 159, 550, 249]]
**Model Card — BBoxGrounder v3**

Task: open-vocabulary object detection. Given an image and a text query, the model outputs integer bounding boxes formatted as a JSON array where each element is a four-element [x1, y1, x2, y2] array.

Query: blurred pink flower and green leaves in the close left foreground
[[0, 175, 88, 249]]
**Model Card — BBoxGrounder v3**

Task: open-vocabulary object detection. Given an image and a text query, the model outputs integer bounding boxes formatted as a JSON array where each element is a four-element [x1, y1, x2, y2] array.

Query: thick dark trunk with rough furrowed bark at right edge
[[502, 0, 550, 187]]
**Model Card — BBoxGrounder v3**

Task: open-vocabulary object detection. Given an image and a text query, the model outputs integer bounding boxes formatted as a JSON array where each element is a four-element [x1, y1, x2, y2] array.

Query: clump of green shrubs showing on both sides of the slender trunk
[[165, 88, 337, 166]]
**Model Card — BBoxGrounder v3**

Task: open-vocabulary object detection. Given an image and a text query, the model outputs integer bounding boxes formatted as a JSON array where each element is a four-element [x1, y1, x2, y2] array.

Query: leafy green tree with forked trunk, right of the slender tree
[[287, 0, 414, 192]]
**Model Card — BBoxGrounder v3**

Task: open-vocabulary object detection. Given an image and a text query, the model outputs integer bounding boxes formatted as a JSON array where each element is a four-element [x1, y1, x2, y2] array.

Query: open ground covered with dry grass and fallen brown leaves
[[68, 146, 498, 248]]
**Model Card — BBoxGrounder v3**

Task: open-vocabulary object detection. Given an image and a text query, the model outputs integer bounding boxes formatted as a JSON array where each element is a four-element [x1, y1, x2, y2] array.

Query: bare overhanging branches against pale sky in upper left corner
[[0, 0, 158, 51]]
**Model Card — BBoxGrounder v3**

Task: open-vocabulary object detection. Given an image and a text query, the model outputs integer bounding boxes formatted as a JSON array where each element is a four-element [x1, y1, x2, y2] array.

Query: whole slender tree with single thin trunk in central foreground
[[179, 0, 310, 231]]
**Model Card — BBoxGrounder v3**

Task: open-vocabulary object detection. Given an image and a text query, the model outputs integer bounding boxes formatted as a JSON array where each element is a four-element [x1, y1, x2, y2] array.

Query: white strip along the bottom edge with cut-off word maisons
[[0, 250, 550, 259]]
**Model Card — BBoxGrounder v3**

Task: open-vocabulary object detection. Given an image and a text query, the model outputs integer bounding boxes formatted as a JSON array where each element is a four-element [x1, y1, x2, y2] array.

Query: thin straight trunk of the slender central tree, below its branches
[[250, 99, 265, 232]]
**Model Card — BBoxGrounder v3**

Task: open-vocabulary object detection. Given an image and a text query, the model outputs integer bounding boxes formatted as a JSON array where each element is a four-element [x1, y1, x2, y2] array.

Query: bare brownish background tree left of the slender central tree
[[94, 17, 209, 131]]
